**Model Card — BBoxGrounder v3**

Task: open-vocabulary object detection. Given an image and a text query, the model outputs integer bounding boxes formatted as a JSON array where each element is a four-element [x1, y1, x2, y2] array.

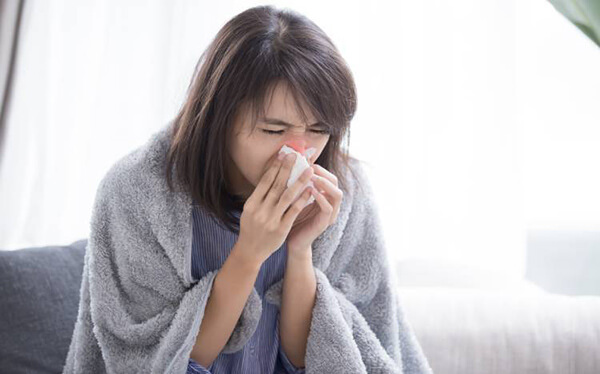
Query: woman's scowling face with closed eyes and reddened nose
[[227, 84, 330, 199]]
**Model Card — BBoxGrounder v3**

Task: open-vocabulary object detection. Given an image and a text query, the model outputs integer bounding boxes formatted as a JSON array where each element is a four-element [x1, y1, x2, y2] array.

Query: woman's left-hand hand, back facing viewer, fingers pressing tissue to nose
[[238, 154, 313, 264]]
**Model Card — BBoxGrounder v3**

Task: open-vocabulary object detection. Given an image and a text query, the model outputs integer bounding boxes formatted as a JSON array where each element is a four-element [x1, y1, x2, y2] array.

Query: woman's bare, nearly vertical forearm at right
[[279, 250, 317, 367]]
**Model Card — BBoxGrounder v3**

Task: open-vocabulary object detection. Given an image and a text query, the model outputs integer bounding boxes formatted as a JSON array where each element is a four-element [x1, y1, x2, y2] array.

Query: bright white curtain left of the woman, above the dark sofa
[[0, 0, 218, 249]]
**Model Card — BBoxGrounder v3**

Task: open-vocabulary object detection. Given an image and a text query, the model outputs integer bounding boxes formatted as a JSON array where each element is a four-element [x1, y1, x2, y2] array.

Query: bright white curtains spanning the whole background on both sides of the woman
[[0, 0, 600, 283]]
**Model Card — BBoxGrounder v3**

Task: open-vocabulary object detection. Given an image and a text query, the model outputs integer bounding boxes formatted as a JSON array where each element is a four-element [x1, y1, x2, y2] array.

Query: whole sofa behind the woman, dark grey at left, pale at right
[[0, 232, 600, 374]]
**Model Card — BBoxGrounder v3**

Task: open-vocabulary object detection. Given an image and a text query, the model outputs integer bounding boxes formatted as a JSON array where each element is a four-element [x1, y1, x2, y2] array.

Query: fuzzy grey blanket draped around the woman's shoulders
[[63, 125, 432, 374]]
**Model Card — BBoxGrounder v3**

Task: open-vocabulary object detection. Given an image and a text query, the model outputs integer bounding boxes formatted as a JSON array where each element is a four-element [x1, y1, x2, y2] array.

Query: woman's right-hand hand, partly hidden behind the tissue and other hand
[[286, 164, 344, 258]]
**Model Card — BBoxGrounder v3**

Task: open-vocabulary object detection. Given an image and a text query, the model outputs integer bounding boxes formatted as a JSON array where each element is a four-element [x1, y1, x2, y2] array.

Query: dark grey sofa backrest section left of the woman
[[0, 239, 87, 374]]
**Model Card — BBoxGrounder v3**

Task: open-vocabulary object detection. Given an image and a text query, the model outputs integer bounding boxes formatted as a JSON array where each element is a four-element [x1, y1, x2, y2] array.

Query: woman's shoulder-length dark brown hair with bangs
[[166, 5, 356, 232]]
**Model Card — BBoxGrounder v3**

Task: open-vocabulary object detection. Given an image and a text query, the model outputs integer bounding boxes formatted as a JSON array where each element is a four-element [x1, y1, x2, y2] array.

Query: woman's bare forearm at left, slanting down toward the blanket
[[190, 243, 261, 367]]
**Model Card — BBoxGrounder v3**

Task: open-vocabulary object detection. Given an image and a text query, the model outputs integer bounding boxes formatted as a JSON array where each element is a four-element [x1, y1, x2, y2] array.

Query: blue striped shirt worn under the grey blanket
[[187, 205, 305, 374]]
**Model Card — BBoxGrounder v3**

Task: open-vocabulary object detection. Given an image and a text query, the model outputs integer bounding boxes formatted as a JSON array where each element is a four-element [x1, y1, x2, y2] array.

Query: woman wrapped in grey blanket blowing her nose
[[63, 6, 431, 373]]
